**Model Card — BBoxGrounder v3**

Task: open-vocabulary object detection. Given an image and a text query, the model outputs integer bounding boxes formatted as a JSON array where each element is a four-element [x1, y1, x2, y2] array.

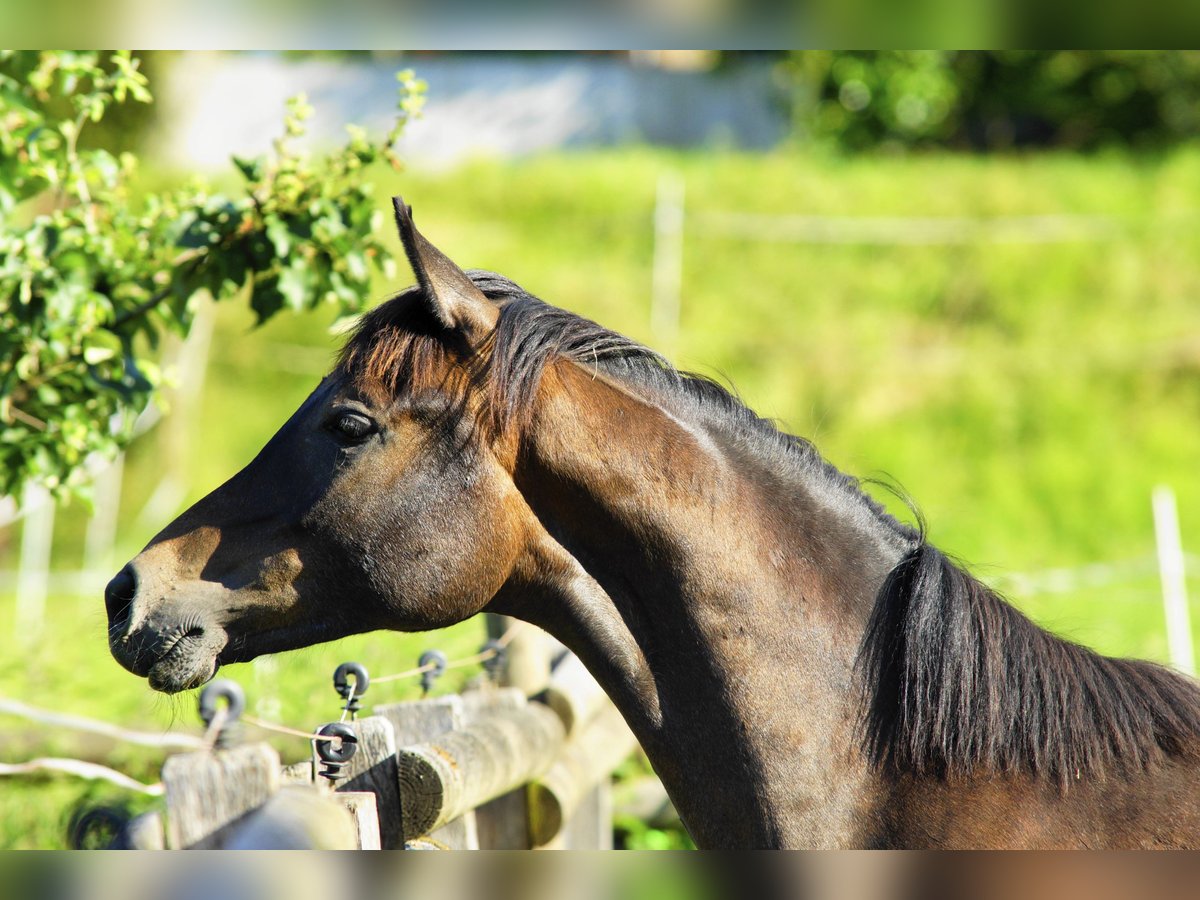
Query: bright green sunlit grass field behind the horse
[[0, 149, 1200, 847]]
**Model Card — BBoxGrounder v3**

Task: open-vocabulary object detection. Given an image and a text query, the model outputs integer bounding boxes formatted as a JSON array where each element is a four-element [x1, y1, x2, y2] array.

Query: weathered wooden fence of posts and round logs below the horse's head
[[120, 629, 637, 850]]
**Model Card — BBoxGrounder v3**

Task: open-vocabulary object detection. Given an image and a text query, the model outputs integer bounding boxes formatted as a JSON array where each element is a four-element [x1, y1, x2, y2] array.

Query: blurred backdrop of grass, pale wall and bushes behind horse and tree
[[0, 50, 1200, 847]]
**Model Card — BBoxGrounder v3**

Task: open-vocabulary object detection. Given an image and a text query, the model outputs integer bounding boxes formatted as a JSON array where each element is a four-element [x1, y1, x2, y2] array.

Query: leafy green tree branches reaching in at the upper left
[[0, 52, 425, 504]]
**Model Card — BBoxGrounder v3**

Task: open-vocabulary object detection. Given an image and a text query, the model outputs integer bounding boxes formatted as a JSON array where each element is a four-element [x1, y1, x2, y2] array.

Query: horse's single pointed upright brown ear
[[391, 197, 500, 338]]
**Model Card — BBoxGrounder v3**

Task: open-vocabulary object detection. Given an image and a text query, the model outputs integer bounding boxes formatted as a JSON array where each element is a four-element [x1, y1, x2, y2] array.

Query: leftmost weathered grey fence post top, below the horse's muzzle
[[162, 744, 281, 850]]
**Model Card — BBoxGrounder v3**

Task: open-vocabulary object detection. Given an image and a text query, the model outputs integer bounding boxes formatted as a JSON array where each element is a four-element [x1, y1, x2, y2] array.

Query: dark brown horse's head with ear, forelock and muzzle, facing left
[[104, 198, 528, 692]]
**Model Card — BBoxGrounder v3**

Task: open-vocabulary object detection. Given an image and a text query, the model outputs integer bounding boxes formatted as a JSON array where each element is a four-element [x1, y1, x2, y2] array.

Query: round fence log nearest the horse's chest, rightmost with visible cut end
[[529, 703, 637, 846]]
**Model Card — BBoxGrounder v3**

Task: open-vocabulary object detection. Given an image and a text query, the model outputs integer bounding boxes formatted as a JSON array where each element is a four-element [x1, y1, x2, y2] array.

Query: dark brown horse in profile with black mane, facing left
[[106, 198, 1200, 848]]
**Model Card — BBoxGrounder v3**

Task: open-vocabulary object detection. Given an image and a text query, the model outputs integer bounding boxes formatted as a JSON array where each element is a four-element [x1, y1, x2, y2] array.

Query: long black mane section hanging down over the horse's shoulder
[[858, 540, 1200, 786]]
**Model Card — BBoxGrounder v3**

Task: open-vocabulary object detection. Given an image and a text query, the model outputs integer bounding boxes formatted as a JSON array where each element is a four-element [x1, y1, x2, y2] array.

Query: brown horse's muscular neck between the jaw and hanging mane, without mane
[[506, 365, 901, 846]]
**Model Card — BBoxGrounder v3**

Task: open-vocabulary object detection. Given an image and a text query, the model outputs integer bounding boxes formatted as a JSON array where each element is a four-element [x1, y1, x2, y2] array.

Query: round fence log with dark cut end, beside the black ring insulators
[[397, 703, 563, 838]]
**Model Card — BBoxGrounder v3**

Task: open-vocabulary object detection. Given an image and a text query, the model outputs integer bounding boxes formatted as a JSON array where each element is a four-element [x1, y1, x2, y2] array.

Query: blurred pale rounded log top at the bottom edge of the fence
[[223, 785, 359, 850]]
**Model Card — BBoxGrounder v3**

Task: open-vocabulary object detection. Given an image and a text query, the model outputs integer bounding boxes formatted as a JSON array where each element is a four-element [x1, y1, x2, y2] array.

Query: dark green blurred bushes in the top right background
[[788, 50, 1200, 150]]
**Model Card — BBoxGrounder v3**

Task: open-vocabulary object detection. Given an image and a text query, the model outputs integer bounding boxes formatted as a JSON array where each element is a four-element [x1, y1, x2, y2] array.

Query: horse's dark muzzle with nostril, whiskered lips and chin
[[104, 565, 228, 694]]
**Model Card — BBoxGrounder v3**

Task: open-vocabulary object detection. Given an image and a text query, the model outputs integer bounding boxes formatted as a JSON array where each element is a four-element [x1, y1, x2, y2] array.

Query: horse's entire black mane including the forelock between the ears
[[340, 270, 1200, 784]]
